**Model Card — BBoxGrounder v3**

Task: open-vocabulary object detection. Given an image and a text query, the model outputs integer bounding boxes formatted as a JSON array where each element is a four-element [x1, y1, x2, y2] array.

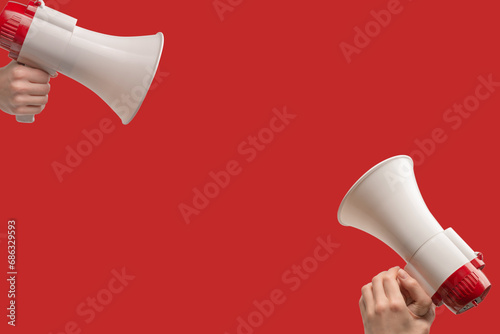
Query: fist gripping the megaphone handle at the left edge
[[0, 61, 50, 115]]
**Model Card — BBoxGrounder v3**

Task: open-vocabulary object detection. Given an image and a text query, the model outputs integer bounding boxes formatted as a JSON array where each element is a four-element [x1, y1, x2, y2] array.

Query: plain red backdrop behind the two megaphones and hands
[[0, 0, 500, 334]]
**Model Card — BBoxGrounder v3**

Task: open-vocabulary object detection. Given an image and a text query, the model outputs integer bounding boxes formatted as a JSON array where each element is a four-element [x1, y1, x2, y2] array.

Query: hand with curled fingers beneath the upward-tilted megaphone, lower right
[[359, 267, 436, 334]]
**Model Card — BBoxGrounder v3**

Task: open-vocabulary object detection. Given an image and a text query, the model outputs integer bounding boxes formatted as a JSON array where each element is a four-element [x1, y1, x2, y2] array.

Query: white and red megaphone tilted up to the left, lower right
[[338, 156, 491, 314]]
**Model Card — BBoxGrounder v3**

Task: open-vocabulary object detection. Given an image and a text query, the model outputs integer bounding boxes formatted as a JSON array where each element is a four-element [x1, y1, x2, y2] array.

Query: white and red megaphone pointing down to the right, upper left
[[0, 1, 163, 124]]
